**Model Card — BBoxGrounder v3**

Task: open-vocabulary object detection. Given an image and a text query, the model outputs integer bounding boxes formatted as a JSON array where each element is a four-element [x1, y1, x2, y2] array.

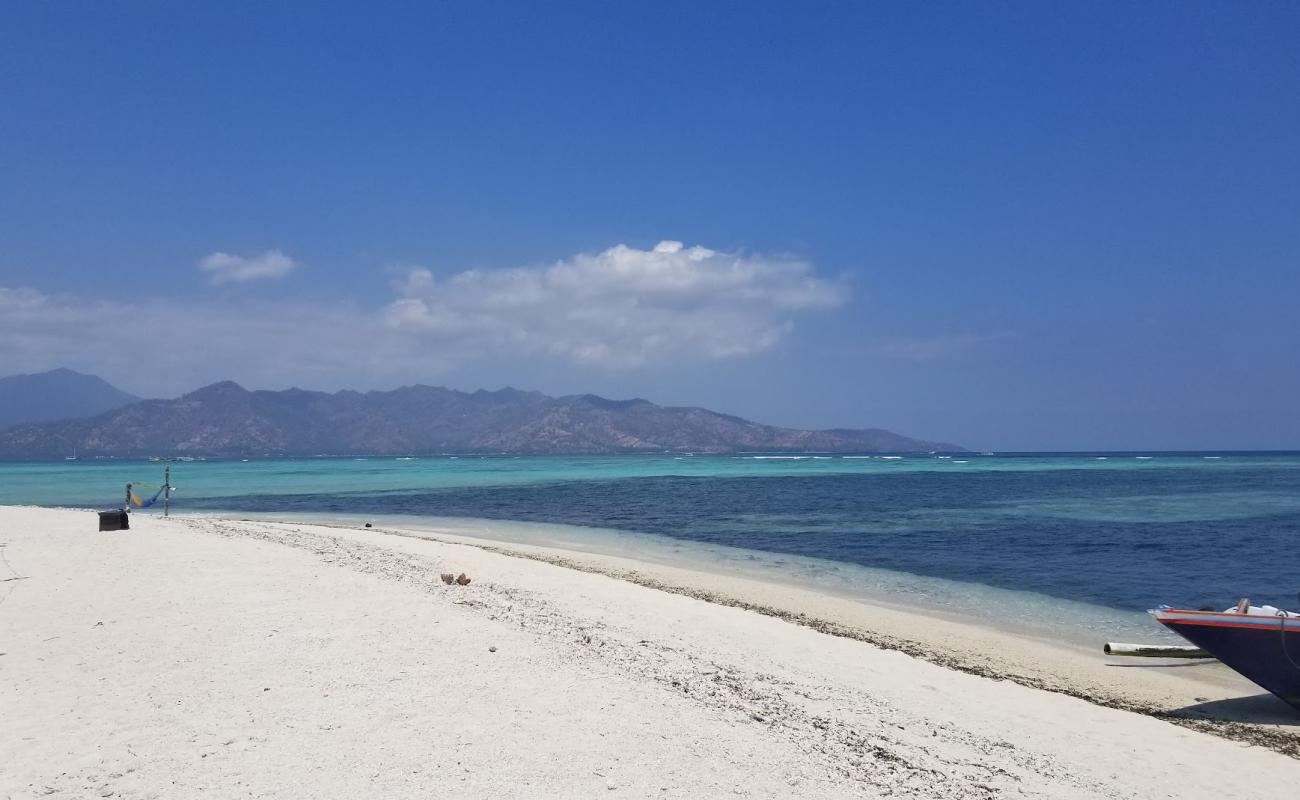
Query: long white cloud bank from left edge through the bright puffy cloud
[[0, 242, 842, 395]]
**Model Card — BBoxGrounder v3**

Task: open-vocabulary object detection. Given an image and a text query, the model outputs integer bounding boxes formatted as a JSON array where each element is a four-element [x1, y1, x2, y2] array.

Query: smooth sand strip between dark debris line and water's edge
[[361, 524, 1300, 757]]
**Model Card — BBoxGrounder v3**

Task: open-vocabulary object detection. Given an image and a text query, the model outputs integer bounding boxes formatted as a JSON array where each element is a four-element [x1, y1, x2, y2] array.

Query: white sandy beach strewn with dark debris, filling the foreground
[[0, 507, 1300, 797]]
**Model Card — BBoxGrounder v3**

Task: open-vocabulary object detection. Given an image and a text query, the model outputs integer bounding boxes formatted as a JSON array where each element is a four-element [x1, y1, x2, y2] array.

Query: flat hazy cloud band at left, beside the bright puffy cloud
[[0, 289, 426, 395]]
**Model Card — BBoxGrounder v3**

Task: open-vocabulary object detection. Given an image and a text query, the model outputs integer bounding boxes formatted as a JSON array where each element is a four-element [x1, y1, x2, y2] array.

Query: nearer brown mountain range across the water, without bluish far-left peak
[[0, 381, 962, 459]]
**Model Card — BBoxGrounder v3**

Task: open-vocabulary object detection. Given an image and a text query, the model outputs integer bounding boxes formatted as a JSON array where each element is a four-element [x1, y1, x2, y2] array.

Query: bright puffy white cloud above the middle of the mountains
[[385, 241, 844, 367]]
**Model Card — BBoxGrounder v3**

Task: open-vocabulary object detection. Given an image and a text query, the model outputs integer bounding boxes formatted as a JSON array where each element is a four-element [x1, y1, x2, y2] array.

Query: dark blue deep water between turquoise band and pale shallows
[[167, 458, 1300, 609]]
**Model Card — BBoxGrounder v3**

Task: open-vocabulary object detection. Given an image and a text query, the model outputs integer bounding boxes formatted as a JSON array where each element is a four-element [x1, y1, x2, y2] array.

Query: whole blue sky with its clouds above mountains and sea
[[0, 3, 1300, 450]]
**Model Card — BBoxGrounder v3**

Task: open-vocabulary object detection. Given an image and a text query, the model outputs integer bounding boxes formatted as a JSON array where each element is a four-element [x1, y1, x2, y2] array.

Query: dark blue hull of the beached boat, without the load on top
[[1160, 619, 1300, 709]]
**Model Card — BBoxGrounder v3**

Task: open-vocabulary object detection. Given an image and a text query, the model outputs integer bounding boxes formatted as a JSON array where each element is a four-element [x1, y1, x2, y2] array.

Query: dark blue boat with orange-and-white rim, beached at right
[[1149, 598, 1300, 710]]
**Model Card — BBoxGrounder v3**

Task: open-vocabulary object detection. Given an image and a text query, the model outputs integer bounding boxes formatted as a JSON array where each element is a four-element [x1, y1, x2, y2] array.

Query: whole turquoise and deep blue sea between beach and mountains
[[0, 453, 1300, 647]]
